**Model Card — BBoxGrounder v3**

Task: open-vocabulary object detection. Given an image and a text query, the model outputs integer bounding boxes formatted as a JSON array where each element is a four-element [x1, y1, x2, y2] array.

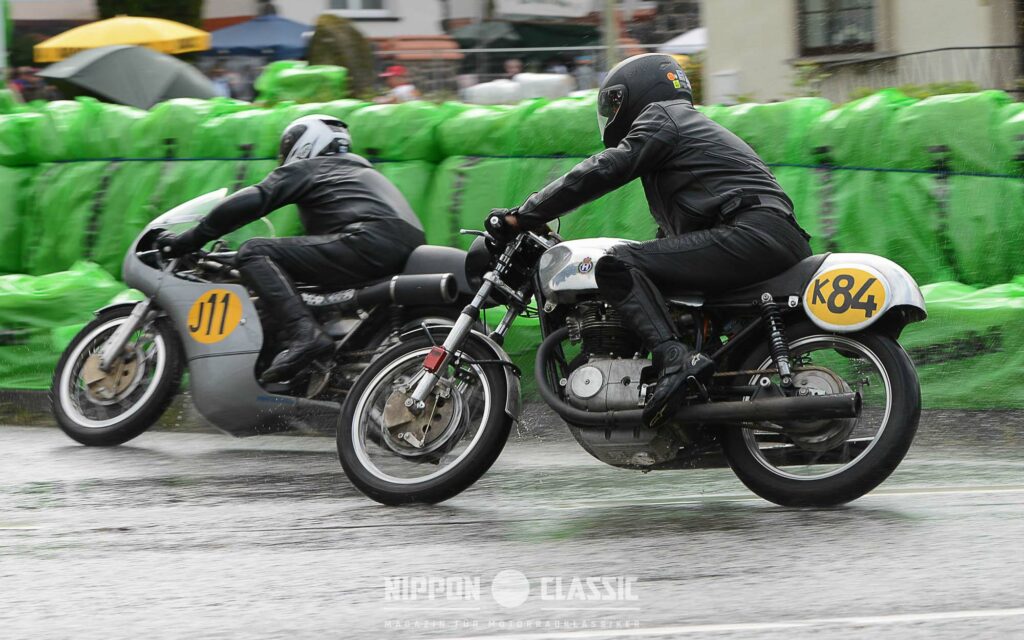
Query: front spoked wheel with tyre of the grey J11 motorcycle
[[50, 307, 183, 446]]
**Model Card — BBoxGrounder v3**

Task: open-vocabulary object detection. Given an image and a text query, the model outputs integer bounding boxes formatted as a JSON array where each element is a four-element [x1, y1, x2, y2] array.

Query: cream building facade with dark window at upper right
[[701, 0, 1024, 103]]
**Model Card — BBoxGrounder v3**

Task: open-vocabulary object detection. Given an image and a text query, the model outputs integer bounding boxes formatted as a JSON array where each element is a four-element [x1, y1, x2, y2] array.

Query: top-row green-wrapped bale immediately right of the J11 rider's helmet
[[348, 101, 447, 162]]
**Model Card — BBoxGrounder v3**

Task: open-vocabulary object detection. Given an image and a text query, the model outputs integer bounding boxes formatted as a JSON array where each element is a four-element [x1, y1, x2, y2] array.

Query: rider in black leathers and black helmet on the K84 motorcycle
[[488, 53, 811, 427]]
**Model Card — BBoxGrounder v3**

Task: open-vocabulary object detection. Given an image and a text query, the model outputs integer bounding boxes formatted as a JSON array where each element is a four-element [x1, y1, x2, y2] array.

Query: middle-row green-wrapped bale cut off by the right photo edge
[[948, 175, 1024, 285]]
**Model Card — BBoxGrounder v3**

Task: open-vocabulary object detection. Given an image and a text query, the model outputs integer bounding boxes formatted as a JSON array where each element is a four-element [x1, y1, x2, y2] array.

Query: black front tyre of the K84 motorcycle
[[338, 336, 513, 506]]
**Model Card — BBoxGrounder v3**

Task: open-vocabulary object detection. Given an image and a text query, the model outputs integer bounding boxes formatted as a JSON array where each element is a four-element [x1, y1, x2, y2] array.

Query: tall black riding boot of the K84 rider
[[596, 257, 715, 427]]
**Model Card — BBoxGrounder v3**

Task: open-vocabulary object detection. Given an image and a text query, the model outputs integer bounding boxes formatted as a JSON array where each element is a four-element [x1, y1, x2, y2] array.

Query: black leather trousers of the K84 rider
[[594, 210, 811, 350]]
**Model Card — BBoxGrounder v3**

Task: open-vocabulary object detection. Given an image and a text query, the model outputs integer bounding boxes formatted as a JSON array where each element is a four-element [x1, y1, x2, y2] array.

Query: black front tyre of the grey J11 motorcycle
[[50, 305, 184, 446]]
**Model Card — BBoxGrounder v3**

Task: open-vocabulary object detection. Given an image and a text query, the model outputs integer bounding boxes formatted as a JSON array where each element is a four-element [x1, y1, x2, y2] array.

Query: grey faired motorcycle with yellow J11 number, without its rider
[[50, 189, 473, 446]]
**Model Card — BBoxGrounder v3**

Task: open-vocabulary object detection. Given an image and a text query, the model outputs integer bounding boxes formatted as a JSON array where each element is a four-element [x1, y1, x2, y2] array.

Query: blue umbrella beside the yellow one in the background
[[208, 15, 312, 60]]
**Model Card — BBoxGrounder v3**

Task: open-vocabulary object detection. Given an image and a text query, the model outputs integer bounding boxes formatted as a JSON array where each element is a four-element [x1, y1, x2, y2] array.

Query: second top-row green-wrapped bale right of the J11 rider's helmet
[[437, 100, 539, 158]]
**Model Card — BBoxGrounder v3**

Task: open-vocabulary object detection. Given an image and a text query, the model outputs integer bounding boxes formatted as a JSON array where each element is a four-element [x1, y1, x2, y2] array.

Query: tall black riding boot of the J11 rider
[[239, 256, 334, 382]]
